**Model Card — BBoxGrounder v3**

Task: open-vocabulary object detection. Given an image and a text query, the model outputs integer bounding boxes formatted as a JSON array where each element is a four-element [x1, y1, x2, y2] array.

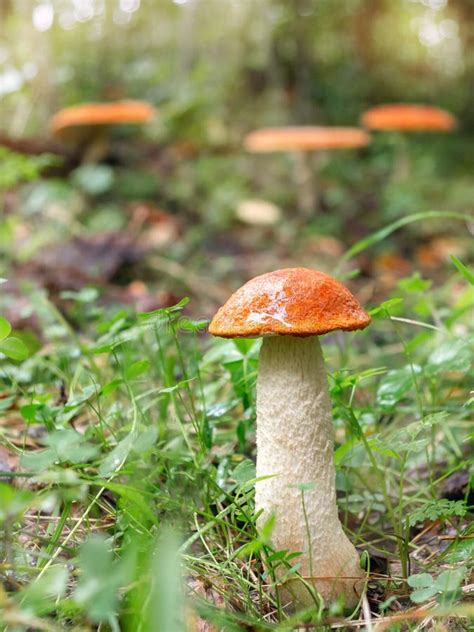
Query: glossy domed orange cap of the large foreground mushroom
[[209, 268, 370, 338]]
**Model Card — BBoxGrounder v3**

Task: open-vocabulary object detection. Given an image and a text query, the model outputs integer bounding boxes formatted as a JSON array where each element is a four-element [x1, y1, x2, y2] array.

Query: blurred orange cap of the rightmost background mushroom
[[361, 103, 456, 132]]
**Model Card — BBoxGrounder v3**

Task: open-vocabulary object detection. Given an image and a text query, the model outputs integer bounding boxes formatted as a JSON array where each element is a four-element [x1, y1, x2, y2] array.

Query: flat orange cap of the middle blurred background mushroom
[[244, 126, 371, 152]]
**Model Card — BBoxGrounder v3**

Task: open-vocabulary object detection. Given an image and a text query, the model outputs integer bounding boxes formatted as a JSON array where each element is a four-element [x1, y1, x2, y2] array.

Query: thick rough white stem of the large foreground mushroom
[[255, 336, 364, 606]]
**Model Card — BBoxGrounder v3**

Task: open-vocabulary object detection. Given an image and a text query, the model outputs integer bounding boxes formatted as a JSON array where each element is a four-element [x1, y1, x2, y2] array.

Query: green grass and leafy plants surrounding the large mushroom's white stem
[[0, 230, 474, 632]]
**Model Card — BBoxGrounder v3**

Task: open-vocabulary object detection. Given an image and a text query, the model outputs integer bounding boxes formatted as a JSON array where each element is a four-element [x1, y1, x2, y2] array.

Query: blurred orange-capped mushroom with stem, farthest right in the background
[[361, 103, 456, 180]]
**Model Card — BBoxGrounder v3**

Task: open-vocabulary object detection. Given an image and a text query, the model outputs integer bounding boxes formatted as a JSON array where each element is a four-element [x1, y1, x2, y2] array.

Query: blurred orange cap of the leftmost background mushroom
[[50, 101, 155, 134]]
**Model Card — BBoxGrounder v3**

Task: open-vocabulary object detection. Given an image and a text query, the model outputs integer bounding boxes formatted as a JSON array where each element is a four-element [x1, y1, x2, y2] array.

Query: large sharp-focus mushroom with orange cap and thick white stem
[[209, 268, 370, 607]]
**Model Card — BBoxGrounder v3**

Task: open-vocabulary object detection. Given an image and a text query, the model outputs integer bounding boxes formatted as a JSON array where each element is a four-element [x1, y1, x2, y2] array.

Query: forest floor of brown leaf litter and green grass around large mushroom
[[0, 146, 474, 632]]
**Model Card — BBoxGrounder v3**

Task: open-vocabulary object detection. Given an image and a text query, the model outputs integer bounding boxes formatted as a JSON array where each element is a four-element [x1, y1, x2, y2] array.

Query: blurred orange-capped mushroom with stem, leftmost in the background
[[50, 101, 155, 162]]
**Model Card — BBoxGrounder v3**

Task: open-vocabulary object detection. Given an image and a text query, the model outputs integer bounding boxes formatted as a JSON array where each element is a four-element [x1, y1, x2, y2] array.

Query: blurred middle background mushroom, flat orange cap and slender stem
[[244, 126, 370, 218]]
